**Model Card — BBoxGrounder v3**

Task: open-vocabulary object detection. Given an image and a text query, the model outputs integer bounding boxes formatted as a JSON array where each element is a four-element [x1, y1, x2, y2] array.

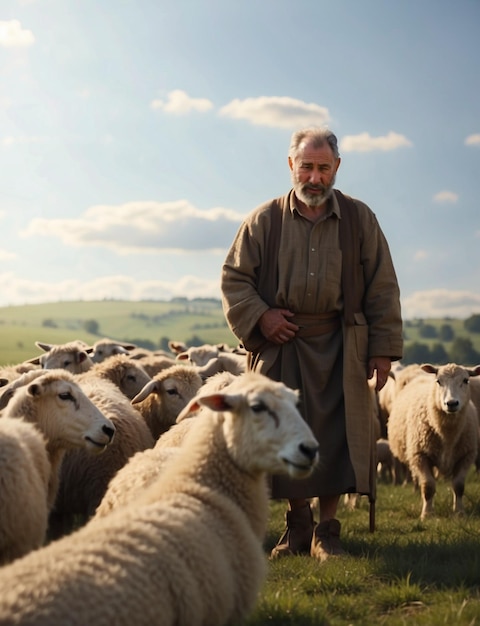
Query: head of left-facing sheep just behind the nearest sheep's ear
[[132, 364, 203, 440]]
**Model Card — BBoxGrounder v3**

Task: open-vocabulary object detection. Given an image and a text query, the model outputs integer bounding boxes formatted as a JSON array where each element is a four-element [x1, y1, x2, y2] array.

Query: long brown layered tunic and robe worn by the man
[[222, 191, 403, 498]]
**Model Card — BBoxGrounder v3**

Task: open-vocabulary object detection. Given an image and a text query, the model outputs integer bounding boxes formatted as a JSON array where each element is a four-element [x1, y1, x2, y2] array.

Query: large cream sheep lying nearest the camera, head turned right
[[0, 372, 318, 626]]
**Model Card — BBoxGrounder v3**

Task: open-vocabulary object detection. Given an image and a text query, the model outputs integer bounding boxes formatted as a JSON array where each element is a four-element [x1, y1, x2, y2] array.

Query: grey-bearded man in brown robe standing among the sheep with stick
[[222, 127, 403, 561]]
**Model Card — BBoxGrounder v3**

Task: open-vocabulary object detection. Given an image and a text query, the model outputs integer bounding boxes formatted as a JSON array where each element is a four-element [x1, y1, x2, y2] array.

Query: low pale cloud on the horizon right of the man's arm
[[402, 289, 480, 319]]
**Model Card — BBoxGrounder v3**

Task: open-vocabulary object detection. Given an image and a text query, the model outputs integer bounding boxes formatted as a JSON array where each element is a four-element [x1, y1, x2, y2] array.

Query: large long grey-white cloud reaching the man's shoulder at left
[[21, 200, 243, 254]]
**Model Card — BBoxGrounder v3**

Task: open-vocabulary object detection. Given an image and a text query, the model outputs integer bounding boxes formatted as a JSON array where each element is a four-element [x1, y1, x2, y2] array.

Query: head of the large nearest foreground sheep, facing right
[[184, 373, 318, 478]]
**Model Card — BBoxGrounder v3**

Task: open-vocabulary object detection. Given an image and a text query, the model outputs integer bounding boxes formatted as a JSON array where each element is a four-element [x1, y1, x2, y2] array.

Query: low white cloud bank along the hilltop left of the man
[[0, 273, 220, 306]]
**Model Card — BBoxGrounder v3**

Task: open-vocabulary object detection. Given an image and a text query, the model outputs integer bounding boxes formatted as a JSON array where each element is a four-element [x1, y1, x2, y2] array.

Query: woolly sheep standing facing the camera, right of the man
[[388, 363, 480, 519]]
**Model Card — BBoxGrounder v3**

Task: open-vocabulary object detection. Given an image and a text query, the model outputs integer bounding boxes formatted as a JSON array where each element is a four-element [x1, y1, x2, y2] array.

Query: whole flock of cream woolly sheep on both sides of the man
[[0, 339, 480, 626]]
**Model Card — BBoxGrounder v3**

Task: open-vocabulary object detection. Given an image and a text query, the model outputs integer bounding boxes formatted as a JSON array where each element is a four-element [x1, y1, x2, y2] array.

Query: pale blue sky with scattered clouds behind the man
[[0, 0, 480, 319]]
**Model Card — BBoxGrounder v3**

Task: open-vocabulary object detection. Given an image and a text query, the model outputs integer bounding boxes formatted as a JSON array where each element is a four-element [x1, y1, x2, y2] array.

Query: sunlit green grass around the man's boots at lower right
[[247, 469, 480, 626]]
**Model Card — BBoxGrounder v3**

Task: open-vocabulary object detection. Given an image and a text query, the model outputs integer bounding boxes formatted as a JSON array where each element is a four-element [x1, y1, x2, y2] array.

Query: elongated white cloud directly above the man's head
[[219, 96, 330, 129]]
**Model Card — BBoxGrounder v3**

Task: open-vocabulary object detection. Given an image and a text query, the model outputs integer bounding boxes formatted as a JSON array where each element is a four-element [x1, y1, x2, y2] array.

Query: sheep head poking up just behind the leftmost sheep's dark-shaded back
[[78, 354, 151, 400]]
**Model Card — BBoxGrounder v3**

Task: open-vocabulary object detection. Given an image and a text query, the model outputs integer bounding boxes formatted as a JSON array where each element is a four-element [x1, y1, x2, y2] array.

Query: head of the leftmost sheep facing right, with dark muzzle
[[6, 370, 115, 453]]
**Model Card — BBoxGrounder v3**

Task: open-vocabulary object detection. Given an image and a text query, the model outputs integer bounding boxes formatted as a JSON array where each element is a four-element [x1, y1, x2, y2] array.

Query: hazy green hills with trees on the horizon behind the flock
[[0, 298, 480, 365]]
